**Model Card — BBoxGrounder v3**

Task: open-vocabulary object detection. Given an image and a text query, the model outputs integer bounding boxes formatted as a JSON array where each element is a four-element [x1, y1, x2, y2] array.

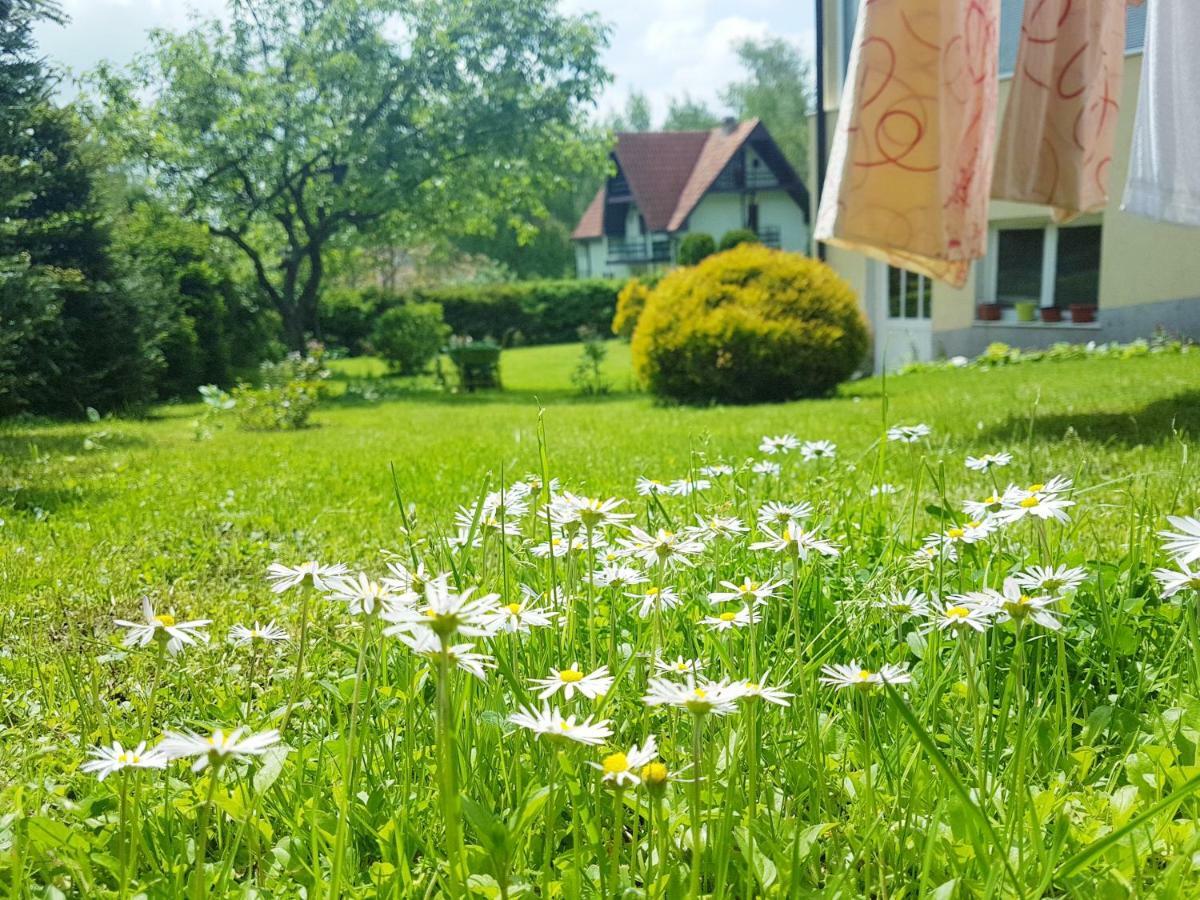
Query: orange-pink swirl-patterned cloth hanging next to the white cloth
[[991, 0, 1126, 223]]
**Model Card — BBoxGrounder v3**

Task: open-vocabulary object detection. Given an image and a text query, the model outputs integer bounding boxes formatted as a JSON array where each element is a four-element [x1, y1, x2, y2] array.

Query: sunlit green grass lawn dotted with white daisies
[[0, 343, 1200, 898]]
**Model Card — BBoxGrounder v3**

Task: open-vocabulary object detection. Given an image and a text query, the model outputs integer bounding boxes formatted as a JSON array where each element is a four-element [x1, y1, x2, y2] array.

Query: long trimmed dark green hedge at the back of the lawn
[[322, 278, 624, 353]]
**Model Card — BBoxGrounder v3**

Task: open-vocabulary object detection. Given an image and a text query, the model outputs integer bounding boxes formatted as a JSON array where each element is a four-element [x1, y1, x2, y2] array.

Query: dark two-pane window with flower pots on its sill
[[979, 224, 1103, 308]]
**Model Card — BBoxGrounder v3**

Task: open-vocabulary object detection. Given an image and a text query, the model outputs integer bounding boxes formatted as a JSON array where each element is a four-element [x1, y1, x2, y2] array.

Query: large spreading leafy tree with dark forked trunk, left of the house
[[101, 0, 607, 349]]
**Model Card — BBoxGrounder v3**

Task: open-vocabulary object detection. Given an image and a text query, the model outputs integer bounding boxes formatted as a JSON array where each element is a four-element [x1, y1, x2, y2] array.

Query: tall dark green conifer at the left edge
[[0, 0, 157, 414]]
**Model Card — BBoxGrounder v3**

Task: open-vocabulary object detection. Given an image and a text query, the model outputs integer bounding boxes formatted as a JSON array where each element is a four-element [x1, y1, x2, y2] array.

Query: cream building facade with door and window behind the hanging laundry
[[810, 0, 1200, 371]]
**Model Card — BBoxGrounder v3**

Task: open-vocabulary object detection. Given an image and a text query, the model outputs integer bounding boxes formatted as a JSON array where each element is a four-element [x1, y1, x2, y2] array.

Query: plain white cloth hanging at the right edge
[[1122, 0, 1200, 226]]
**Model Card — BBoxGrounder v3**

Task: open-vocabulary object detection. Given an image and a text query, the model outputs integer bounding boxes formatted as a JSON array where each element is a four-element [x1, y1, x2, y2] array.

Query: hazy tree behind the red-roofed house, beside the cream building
[[721, 37, 812, 175]]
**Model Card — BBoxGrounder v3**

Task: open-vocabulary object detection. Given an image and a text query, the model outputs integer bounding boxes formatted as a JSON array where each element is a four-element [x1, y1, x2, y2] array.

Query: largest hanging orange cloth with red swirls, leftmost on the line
[[815, 0, 1000, 287]]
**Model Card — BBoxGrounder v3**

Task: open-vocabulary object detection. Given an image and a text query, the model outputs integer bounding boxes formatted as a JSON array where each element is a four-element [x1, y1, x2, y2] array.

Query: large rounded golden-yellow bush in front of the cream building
[[632, 244, 868, 403]]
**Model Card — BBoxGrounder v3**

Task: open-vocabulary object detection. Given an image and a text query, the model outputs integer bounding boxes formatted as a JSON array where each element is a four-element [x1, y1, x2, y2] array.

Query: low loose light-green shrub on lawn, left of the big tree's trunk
[[230, 344, 329, 431]]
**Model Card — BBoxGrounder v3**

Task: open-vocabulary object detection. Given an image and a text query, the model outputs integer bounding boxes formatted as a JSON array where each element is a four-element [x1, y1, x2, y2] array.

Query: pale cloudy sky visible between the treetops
[[37, 0, 814, 119]]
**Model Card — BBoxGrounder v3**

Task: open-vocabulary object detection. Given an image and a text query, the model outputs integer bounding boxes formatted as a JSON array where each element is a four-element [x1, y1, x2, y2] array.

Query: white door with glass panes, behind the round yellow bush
[[869, 260, 934, 372]]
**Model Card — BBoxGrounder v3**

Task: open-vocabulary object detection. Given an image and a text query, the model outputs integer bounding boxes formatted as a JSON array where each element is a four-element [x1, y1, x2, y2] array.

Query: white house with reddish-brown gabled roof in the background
[[571, 119, 809, 277]]
